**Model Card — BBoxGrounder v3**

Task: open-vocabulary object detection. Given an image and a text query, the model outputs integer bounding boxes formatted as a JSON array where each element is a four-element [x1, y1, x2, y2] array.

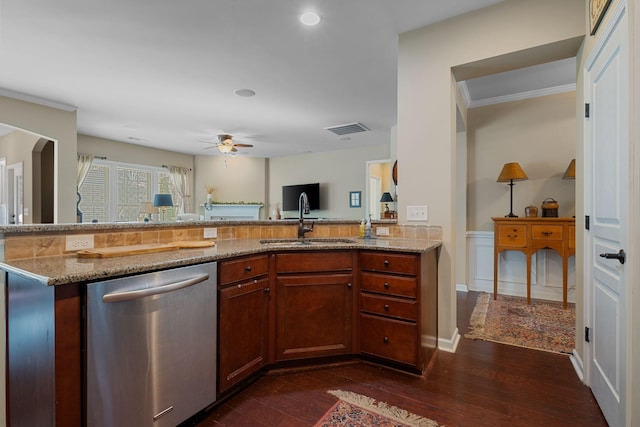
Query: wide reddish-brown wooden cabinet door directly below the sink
[[276, 274, 353, 360]]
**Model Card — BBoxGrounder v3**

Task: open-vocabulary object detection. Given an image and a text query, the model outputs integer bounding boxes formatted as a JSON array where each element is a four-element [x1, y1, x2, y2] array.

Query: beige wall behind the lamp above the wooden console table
[[467, 92, 577, 231]]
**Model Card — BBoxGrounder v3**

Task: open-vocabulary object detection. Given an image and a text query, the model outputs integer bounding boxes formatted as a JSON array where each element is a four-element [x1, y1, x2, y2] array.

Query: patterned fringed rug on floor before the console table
[[464, 292, 576, 354]]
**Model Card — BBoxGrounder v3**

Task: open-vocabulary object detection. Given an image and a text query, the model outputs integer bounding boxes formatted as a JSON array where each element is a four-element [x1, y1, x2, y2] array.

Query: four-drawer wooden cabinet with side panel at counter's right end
[[360, 251, 437, 372]]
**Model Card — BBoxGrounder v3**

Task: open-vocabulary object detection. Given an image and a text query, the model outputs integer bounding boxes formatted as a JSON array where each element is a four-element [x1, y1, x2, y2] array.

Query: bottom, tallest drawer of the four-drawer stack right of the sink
[[360, 314, 418, 366]]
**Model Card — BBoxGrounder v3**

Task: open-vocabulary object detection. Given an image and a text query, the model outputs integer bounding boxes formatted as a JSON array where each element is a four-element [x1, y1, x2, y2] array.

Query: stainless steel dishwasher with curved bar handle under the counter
[[87, 263, 217, 427]]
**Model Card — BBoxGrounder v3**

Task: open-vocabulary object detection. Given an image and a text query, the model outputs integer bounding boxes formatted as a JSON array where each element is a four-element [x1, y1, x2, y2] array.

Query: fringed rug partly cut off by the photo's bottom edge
[[314, 390, 438, 427]]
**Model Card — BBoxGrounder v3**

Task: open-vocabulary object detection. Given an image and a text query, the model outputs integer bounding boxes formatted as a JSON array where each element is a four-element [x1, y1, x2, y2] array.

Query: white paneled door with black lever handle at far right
[[584, 2, 630, 426]]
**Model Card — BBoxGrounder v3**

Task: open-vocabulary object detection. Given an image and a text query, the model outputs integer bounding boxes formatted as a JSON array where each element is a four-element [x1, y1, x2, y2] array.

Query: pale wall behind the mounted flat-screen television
[[269, 145, 389, 219]]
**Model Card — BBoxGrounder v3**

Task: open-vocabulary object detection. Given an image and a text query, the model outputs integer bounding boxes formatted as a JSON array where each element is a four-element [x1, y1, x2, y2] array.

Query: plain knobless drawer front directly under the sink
[[276, 251, 353, 273]]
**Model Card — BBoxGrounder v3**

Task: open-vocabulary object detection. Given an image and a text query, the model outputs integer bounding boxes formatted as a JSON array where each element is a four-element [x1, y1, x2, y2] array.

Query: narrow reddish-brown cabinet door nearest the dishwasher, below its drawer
[[218, 278, 269, 393]]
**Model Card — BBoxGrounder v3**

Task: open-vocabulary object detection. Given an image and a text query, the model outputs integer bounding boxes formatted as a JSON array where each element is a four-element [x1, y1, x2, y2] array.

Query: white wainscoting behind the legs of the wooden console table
[[467, 231, 576, 302]]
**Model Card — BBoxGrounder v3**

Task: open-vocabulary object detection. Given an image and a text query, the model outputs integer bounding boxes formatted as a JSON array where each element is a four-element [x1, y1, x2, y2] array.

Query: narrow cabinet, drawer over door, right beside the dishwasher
[[218, 255, 271, 393]]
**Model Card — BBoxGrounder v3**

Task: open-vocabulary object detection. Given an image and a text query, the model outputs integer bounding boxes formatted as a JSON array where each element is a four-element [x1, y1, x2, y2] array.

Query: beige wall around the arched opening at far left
[[0, 96, 77, 223]]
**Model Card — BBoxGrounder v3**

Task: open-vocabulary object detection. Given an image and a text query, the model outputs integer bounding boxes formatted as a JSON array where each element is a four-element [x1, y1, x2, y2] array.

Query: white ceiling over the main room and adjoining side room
[[0, 0, 575, 157]]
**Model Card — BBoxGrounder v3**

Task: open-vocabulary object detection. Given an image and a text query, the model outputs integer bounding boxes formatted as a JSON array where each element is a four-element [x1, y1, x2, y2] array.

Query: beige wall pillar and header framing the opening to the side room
[[397, 0, 585, 346]]
